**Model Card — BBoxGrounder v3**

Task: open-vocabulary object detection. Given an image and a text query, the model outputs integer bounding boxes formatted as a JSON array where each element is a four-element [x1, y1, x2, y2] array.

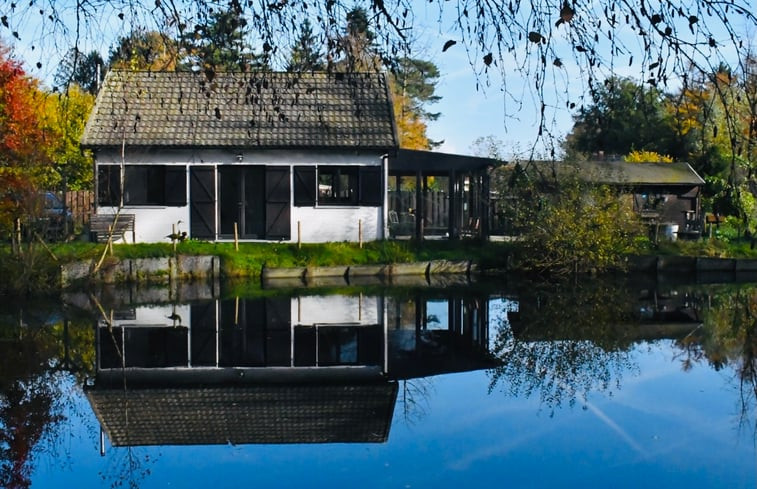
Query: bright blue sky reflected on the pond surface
[[8, 278, 757, 489]]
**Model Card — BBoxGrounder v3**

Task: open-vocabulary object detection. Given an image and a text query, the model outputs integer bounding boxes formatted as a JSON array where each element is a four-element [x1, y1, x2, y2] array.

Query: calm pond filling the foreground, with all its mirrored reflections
[[0, 278, 757, 489]]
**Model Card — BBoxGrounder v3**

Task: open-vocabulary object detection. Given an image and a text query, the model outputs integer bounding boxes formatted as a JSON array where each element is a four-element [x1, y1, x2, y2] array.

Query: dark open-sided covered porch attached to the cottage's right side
[[386, 149, 497, 240]]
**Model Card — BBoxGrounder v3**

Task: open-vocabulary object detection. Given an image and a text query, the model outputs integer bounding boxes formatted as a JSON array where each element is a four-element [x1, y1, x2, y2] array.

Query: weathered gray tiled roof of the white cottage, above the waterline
[[81, 71, 397, 149]]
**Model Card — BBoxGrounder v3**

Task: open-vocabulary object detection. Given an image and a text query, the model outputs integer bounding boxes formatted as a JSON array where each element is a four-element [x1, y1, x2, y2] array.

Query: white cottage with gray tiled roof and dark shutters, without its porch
[[81, 71, 398, 242]]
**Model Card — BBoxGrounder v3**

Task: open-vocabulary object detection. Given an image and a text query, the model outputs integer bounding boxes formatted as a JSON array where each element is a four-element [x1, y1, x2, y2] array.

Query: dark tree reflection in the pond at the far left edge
[[0, 306, 94, 489]]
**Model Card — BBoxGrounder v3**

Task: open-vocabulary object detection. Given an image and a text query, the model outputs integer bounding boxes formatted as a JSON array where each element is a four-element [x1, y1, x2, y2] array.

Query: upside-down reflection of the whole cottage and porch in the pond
[[87, 291, 496, 446]]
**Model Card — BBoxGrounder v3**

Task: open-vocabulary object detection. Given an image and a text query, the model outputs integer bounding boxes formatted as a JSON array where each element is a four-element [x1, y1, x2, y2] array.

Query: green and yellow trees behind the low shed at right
[[564, 55, 757, 224]]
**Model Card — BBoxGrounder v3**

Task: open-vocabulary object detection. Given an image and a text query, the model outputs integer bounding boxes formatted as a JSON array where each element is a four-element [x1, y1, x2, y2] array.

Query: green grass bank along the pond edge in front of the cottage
[[0, 240, 509, 295]]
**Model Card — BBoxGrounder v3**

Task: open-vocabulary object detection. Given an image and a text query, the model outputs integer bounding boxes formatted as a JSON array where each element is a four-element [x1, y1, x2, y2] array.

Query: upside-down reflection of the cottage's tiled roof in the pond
[[87, 382, 397, 446]]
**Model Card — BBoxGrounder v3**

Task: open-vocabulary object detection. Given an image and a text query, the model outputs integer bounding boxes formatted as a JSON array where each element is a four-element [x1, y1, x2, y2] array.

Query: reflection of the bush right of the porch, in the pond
[[490, 280, 660, 413]]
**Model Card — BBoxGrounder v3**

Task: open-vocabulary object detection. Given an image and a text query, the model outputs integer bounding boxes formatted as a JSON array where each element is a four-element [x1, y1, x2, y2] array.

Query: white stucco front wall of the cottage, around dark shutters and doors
[[97, 150, 385, 243]]
